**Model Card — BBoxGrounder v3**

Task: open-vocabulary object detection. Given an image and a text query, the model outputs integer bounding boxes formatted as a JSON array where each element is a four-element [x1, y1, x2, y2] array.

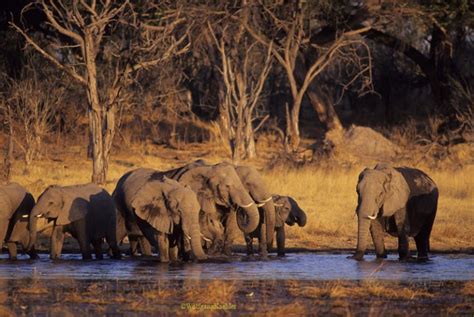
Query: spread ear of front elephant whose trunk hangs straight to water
[[130, 181, 173, 234]]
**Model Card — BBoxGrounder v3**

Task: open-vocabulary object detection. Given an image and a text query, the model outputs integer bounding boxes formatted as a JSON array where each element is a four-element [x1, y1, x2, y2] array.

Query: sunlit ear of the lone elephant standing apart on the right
[[375, 164, 410, 217]]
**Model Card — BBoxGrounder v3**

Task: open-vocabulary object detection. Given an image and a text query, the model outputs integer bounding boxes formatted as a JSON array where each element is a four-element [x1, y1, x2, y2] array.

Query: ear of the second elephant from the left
[[56, 188, 89, 225]]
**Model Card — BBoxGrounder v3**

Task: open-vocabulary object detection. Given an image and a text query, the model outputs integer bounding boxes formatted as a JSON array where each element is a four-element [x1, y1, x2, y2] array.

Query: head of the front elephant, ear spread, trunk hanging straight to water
[[128, 178, 206, 259]]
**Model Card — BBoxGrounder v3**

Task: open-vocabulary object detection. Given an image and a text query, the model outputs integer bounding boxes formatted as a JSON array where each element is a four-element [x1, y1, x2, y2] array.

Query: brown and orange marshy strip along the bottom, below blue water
[[0, 279, 474, 316]]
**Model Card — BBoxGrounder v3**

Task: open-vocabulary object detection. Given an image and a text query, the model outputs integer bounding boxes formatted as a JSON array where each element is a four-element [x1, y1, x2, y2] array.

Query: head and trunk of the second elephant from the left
[[28, 185, 88, 249]]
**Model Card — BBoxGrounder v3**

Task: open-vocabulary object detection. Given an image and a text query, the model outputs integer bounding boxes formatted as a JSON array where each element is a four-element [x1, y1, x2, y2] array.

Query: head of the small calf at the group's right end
[[273, 195, 306, 227]]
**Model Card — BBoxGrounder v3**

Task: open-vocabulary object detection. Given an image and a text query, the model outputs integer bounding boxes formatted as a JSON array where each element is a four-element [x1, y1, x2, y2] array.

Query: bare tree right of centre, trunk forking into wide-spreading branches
[[245, 3, 370, 151]]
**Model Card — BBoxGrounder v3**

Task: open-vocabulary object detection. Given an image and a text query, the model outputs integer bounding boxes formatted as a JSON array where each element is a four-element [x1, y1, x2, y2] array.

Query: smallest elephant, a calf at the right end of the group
[[244, 195, 306, 256]]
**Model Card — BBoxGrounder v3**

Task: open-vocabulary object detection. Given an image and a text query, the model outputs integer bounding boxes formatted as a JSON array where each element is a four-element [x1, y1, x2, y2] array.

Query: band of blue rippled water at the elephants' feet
[[0, 253, 474, 285]]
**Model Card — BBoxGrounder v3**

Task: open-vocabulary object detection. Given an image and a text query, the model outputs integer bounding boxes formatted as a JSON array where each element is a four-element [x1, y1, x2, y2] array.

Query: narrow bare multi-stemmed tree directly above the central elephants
[[208, 1, 272, 161]]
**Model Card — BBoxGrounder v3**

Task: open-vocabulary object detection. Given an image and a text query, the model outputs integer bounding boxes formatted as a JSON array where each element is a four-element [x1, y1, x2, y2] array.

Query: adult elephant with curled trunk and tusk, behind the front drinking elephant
[[164, 160, 260, 254]]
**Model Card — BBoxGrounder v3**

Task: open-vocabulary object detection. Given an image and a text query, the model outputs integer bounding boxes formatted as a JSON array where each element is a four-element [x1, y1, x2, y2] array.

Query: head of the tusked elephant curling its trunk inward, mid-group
[[179, 163, 259, 233]]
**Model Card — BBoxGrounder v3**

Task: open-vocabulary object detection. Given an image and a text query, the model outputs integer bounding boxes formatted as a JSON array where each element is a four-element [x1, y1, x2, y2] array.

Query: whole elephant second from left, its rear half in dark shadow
[[29, 184, 121, 259]]
